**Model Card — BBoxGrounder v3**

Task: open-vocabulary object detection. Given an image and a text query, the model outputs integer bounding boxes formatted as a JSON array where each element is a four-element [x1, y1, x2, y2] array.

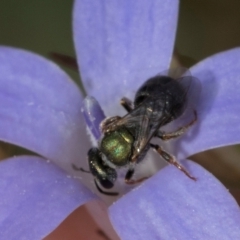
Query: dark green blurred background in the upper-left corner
[[0, 0, 79, 81]]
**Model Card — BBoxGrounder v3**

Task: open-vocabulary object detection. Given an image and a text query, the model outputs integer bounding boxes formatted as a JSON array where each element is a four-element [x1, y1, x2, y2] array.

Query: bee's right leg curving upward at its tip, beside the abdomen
[[156, 110, 197, 141]]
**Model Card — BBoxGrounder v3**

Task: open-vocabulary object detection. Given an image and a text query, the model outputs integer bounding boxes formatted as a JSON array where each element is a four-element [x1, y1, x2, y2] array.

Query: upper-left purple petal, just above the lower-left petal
[[0, 47, 90, 170]]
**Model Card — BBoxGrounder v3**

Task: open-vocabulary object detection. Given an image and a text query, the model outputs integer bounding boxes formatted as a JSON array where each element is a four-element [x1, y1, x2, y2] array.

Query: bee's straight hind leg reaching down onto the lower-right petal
[[150, 143, 197, 181]]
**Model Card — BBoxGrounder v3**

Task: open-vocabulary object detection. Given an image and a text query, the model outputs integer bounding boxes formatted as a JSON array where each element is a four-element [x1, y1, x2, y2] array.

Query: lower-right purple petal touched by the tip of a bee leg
[[110, 162, 240, 240]]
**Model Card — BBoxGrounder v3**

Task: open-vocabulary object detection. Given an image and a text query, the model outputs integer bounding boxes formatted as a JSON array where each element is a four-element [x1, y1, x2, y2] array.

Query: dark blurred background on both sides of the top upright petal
[[0, 0, 240, 78]]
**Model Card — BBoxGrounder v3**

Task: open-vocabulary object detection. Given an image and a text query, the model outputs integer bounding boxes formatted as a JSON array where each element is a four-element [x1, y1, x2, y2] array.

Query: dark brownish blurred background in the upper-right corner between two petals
[[176, 0, 240, 61]]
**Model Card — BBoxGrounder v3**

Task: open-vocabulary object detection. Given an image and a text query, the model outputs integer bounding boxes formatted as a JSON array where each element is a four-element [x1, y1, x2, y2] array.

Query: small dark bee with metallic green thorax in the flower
[[75, 69, 200, 196]]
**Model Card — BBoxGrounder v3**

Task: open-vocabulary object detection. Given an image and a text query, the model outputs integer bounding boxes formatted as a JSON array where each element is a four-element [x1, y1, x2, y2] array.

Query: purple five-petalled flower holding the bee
[[0, 0, 240, 239]]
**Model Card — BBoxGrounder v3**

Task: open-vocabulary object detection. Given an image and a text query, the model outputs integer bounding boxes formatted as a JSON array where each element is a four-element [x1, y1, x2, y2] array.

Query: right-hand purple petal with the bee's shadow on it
[[172, 48, 240, 158]]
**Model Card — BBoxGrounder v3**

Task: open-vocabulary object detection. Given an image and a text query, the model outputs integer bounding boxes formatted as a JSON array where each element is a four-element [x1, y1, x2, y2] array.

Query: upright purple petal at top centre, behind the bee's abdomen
[[73, 0, 178, 114]]
